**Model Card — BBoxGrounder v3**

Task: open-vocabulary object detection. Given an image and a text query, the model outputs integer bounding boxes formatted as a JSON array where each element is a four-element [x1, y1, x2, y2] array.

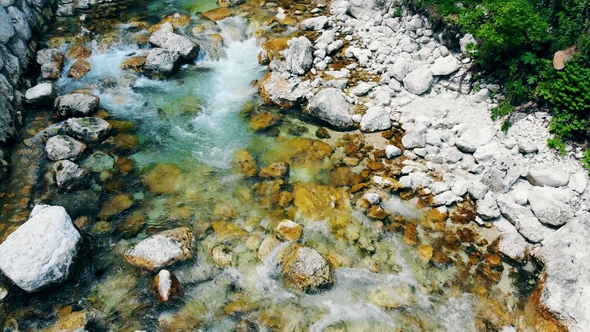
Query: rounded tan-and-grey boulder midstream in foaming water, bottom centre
[[283, 246, 334, 293]]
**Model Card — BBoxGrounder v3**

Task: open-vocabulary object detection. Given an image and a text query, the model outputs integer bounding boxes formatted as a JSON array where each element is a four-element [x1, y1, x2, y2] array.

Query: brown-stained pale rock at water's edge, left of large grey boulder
[[258, 72, 310, 109]]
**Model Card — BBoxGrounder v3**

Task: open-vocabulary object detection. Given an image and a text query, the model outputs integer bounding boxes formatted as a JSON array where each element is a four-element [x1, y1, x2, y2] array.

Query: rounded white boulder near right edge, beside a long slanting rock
[[528, 187, 573, 226]]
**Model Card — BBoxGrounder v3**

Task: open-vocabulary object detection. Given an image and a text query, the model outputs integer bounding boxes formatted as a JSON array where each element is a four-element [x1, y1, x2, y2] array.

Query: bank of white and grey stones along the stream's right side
[[260, 0, 590, 331]]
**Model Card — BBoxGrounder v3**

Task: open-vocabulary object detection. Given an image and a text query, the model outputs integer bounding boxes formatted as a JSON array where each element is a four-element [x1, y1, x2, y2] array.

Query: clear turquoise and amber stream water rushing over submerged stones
[[0, 0, 568, 331]]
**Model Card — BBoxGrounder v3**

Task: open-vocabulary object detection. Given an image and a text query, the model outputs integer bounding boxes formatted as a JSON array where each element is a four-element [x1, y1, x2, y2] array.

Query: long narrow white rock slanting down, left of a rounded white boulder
[[497, 195, 554, 243]]
